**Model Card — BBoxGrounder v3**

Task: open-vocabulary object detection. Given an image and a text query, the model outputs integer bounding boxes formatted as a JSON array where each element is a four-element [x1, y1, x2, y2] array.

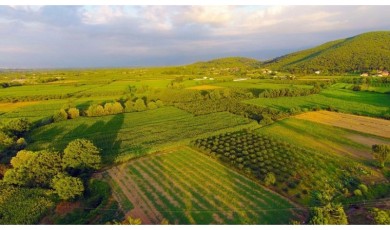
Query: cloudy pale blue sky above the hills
[[0, 5, 390, 68]]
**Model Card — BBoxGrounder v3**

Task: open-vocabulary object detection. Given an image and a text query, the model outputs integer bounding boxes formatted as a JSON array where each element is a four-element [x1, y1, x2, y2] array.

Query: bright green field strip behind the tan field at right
[[246, 89, 390, 116]]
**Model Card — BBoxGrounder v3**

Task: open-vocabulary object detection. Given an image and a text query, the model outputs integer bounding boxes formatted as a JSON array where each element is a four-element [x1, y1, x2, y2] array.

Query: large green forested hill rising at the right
[[264, 31, 390, 74]]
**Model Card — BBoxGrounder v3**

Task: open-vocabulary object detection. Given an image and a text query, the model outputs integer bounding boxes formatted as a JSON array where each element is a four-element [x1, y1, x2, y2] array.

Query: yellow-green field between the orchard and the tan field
[[255, 118, 390, 161]]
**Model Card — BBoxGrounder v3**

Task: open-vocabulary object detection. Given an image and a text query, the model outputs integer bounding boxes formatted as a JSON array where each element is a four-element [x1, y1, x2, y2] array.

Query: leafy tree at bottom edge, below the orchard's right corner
[[309, 203, 348, 225]]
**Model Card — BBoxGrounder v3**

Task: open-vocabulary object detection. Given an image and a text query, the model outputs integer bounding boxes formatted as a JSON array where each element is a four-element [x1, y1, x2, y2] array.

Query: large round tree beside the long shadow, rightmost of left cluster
[[62, 139, 101, 172]]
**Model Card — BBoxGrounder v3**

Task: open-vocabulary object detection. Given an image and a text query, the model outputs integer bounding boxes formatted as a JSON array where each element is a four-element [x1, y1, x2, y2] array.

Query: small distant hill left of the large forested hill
[[189, 57, 261, 69]]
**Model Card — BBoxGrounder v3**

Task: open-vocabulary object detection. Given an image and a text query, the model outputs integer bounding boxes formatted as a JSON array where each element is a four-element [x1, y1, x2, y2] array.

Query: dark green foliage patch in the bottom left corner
[[0, 185, 54, 225]]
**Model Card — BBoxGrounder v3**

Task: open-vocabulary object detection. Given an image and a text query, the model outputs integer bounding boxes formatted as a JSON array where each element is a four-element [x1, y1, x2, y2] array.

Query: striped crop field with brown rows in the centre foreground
[[103, 147, 304, 224]]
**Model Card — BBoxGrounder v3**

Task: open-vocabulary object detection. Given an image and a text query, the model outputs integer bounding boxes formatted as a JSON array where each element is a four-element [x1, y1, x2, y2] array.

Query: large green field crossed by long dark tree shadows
[[28, 107, 250, 163]]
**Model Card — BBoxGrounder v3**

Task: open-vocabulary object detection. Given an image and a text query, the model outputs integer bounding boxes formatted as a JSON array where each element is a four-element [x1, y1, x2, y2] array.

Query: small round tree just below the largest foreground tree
[[52, 173, 84, 200]]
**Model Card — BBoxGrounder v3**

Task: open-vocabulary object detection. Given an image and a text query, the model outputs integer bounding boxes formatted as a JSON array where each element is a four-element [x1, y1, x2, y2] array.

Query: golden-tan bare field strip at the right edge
[[295, 111, 390, 138]]
